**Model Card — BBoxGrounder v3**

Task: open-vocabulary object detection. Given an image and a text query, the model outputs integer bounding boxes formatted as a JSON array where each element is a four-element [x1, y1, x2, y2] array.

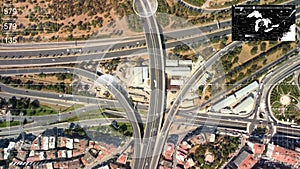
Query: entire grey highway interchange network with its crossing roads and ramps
[[0, 0, 300, 169]]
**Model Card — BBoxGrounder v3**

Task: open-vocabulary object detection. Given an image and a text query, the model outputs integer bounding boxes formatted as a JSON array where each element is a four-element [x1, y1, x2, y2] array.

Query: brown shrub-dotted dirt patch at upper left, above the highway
[[5, 0, 131, 43]]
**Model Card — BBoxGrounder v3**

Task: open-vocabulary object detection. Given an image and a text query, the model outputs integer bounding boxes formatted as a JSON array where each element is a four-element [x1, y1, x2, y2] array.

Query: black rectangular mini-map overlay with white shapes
[[232, 5, 296, 41]]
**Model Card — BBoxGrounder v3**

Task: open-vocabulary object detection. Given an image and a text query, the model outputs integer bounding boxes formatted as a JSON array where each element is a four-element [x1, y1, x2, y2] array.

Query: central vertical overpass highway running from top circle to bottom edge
[[134, 0, 166, 169]]
